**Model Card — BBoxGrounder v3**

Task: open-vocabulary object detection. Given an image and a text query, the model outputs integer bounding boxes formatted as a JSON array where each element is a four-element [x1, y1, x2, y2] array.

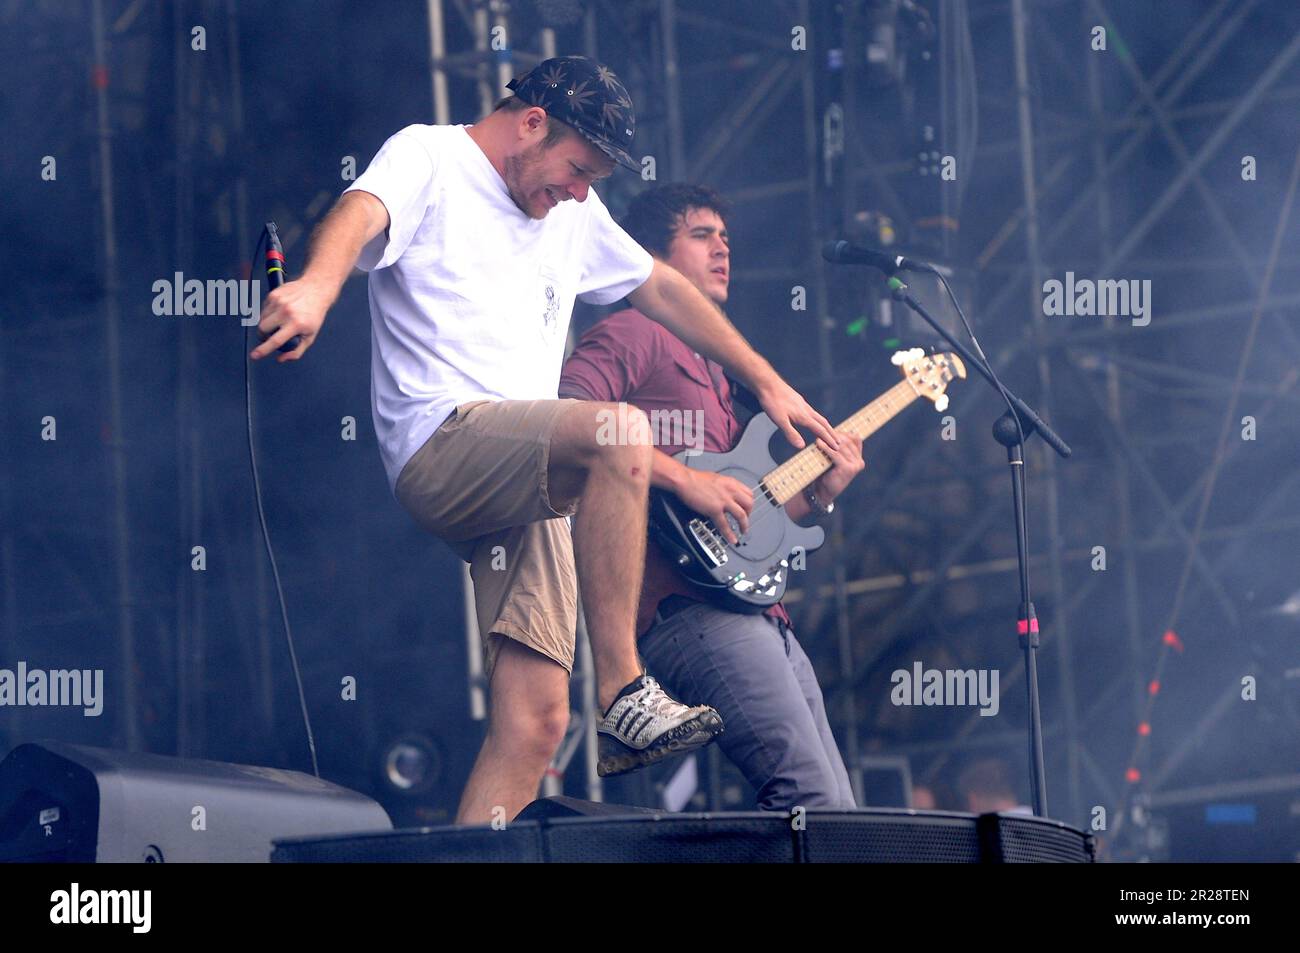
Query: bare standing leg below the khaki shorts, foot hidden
[[456, 636, 569, 824]]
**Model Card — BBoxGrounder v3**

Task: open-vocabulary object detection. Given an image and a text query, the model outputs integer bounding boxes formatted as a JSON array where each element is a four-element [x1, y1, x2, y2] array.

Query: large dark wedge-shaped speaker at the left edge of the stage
[[0, 741, 393, 863]]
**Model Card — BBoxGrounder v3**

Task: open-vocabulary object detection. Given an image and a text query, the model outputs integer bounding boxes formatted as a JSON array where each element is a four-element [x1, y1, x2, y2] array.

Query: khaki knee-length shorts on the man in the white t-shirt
[[395, 400, 577, 680]]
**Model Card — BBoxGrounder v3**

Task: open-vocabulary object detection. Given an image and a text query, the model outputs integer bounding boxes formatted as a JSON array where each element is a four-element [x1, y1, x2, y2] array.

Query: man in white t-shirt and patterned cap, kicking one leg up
[[251, 56, 836, 823]]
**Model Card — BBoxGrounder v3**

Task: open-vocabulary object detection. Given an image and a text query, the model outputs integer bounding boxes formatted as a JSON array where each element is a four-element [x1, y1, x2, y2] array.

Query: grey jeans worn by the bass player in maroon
[[637, 603, 857, 811]]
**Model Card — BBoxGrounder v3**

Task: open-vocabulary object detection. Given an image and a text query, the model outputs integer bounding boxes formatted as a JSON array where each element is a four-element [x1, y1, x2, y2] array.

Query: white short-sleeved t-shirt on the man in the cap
[[347, 125, 654, 490]]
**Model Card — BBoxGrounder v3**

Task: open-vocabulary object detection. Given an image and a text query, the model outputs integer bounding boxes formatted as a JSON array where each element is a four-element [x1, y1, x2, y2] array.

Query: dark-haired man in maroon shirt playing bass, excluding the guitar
[[559, 185, 866, 811]]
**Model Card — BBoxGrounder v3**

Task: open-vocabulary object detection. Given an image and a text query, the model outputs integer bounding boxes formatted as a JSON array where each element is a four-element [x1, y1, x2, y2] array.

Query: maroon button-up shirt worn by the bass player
[[559, 308, 790, 636]]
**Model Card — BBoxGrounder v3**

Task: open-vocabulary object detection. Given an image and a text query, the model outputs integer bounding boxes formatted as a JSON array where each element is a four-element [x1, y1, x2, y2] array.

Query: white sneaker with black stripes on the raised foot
[[595, 675, 723, 777]]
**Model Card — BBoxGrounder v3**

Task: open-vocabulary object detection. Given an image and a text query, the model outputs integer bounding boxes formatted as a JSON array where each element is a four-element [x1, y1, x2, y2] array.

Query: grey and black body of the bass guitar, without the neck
[[650, 413, 826, 612]]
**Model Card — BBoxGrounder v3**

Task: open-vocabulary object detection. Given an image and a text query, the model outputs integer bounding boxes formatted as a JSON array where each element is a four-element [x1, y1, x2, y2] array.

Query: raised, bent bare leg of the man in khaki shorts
[[549, 402, 654, 711]]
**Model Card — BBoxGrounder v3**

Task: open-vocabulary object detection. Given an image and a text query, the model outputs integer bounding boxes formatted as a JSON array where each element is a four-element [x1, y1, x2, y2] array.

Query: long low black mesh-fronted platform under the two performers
[[270, 798, 1096, 863]]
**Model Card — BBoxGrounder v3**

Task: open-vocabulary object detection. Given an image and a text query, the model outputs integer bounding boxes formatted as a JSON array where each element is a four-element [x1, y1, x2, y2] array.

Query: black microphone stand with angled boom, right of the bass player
[[889, 276, 1073, 818]]
